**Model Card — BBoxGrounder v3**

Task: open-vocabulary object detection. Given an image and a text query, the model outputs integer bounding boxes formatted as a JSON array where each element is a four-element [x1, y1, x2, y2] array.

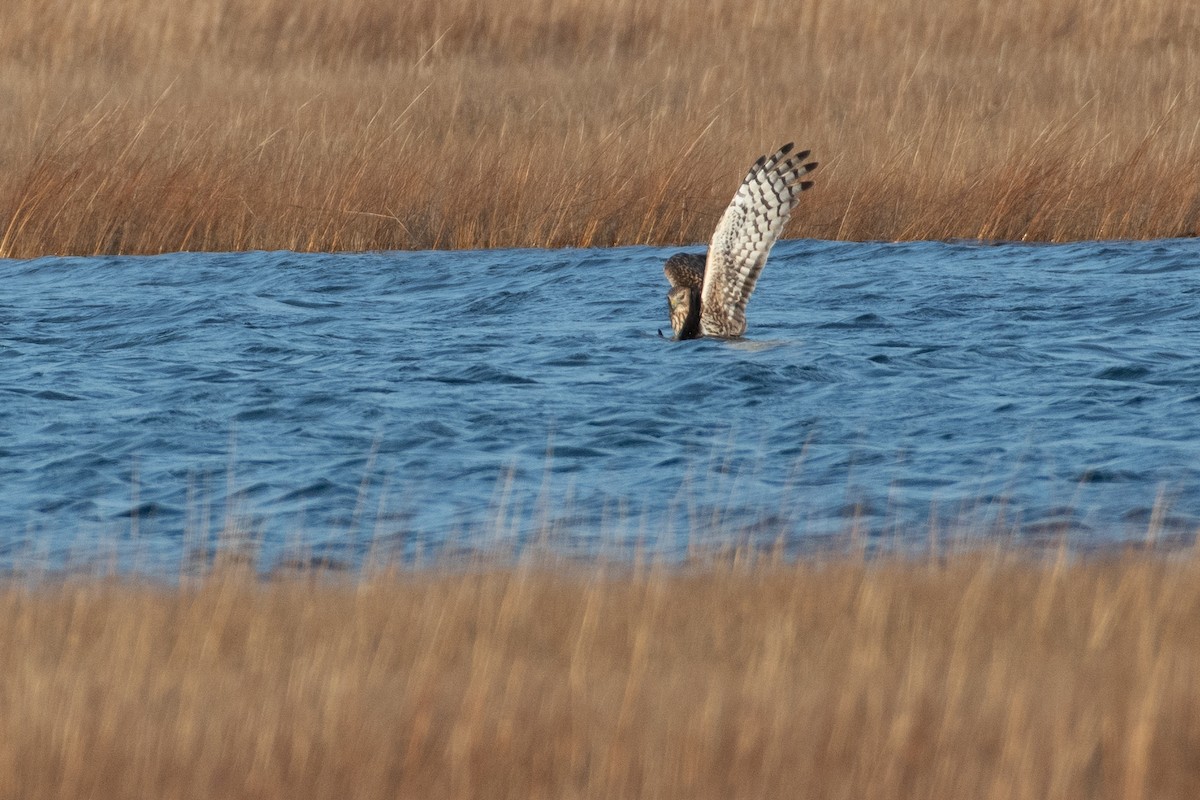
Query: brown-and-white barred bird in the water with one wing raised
[[660, 142, 817, 339]]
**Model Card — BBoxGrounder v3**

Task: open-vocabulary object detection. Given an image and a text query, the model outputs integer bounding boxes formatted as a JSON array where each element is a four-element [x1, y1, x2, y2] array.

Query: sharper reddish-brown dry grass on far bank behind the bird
[[0, 0, 1200, 255]]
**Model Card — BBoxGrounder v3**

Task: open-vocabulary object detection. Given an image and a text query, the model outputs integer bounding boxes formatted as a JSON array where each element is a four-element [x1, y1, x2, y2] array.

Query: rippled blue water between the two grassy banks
[[0, 240, 1200, 567]]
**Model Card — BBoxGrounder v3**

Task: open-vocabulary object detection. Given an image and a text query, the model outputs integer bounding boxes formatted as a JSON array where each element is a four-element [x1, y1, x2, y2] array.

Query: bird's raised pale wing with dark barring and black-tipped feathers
[[700, 143, 817, 336]]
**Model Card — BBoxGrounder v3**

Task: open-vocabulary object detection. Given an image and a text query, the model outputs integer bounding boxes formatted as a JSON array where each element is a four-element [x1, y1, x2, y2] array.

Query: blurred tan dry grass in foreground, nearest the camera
[[0, 553, 1200, 800]]
